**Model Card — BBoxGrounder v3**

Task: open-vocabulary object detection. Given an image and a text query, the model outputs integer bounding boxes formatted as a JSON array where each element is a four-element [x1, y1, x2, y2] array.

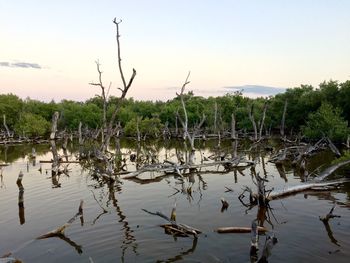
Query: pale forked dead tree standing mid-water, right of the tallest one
[[176, 72, 206, 151]]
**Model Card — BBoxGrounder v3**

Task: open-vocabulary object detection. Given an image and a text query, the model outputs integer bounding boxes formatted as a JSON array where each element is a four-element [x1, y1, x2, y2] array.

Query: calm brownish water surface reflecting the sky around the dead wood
[[0, 141, 350, 262]]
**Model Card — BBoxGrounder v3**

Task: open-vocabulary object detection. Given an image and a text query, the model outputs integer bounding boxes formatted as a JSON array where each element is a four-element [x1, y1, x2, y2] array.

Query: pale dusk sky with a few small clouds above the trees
[[0, 0, 350, 102]]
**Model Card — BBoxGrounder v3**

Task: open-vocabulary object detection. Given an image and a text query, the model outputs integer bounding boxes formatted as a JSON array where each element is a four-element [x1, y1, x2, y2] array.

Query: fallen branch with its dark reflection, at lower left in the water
[[36, 200, 84, 254]]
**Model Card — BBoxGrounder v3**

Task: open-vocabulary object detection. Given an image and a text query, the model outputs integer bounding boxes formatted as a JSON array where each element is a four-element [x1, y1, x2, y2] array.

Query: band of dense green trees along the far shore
[[0, 80, 350, 141]]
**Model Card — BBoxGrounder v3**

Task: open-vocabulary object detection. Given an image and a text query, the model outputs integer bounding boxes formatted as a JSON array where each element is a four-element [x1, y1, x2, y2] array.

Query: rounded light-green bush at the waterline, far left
[[15, 112, 50, 137]]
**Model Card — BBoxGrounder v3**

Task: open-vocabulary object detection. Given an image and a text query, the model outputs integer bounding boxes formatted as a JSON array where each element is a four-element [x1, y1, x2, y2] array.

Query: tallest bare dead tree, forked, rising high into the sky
[[101, 18, 136, 151]]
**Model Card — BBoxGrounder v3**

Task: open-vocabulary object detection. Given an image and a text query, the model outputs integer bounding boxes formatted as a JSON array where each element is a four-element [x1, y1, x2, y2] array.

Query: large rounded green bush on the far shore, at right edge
[[302, 103, 349, 141]]
